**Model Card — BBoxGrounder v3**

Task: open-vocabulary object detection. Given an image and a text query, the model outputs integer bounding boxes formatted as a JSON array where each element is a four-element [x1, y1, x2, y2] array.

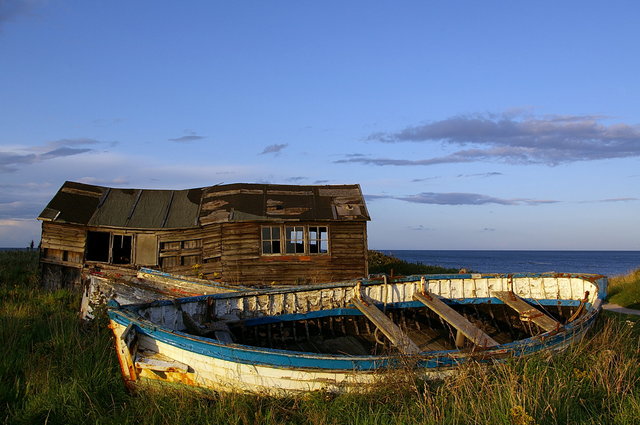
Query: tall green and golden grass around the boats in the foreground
[[0, 252, 640, 425]]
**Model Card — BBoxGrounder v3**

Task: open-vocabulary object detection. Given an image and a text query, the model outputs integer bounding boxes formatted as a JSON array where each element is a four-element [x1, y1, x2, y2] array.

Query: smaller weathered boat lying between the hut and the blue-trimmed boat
[[80, 268, 249, 319]]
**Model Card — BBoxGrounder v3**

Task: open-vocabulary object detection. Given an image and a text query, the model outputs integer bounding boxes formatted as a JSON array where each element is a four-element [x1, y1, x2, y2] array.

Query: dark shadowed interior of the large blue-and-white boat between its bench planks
[[179, 294, 585, 355]]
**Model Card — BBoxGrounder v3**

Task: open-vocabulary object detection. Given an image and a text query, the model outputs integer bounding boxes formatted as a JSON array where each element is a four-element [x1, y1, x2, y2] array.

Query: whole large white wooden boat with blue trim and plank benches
[[108, 273, 607, 394]]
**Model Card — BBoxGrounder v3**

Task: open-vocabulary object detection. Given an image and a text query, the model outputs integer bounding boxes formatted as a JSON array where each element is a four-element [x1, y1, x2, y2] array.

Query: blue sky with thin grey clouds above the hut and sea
[[0, 0, 640, 250]]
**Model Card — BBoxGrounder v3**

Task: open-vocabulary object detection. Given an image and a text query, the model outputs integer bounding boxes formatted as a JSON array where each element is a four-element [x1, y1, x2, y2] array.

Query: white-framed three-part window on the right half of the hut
[[262, 226, 329, 255]]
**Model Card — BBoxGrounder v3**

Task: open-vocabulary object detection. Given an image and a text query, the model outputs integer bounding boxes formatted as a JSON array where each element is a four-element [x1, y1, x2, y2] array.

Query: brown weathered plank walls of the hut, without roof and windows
[[42, 221, 367, 286]]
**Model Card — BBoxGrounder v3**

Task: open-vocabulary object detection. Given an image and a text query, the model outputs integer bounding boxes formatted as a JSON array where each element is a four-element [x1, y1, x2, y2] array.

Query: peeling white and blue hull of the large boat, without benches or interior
[[109, 275, 606, 395]]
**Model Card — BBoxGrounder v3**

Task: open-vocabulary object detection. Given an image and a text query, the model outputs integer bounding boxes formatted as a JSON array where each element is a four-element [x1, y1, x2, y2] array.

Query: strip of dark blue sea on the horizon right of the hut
[[377, 249, 640, 276]]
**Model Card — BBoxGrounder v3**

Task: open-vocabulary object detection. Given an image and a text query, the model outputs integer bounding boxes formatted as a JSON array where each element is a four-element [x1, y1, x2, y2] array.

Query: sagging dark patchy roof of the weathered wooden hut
[[38, 181, 370, 229]]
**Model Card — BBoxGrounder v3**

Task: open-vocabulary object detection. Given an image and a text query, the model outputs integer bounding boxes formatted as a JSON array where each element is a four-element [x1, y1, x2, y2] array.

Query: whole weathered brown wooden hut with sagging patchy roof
[[38, 182, 369, 287]]
